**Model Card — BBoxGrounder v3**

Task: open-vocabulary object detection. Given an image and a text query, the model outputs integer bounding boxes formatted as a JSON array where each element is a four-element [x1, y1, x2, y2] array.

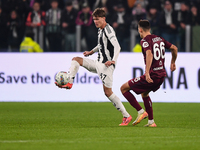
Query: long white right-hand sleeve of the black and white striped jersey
[[105, 25, 121, 62]]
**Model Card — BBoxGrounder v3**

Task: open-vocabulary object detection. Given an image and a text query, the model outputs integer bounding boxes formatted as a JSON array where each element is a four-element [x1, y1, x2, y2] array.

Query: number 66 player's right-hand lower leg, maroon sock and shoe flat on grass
[[141, 91, 157, 127]]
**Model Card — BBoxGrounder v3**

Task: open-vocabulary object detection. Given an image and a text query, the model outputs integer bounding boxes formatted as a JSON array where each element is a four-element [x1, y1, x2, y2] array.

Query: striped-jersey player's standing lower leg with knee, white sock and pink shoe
[[103, 85, 132, 126]]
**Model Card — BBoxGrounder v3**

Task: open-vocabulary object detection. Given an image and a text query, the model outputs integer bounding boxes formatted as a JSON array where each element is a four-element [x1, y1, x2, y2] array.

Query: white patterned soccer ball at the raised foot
[[55, 71, 70, 85]]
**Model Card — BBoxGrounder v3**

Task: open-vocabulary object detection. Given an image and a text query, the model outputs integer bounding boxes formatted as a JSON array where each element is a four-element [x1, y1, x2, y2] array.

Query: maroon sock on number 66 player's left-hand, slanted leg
[[123, 91, 142, 111]]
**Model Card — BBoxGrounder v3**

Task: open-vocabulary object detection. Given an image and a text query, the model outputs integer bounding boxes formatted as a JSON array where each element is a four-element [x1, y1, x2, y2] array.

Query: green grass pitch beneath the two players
[[0, 102, 200, 150]]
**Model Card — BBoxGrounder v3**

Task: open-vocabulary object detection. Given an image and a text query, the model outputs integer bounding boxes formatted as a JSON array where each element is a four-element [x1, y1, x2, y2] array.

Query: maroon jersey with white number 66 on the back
[[140, 34, 172, 78]]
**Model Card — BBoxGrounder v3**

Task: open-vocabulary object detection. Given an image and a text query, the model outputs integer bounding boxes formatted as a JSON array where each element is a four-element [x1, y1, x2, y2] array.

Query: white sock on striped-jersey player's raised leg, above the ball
[[68, 60, 80, 83]]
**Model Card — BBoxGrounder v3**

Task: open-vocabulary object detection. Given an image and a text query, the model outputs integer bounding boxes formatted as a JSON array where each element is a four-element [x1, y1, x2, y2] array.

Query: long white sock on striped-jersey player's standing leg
[[108, 93, 130, 118]]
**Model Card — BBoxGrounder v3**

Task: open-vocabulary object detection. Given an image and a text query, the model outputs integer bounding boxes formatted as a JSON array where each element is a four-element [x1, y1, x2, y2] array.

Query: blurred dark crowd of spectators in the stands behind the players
[[0, 0, 200, 52]]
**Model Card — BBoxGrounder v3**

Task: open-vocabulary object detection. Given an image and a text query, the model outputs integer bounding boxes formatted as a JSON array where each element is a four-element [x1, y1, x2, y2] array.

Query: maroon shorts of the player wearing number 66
[[128, 75, 164, 94]]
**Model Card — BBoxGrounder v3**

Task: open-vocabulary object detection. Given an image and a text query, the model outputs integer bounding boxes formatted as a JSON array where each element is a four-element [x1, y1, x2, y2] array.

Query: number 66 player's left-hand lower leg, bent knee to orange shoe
[[121, 82, 148, 125]]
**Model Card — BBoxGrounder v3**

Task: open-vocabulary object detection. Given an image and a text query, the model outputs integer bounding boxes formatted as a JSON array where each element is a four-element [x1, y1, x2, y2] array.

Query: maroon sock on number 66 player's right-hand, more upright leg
[[142, 96, 153, 120]]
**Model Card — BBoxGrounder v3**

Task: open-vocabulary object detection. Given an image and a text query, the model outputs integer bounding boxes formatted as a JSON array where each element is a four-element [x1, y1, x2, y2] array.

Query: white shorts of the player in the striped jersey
[[83, 58, 115, 88]]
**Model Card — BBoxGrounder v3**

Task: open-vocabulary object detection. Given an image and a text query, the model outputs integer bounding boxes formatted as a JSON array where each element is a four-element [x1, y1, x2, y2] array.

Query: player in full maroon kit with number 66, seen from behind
[[121, 20, 178, 127]]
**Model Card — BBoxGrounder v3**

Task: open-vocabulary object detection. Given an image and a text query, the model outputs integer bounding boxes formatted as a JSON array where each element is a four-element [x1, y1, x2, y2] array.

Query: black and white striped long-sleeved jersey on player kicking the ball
[[93, 24, 121, 63]]
